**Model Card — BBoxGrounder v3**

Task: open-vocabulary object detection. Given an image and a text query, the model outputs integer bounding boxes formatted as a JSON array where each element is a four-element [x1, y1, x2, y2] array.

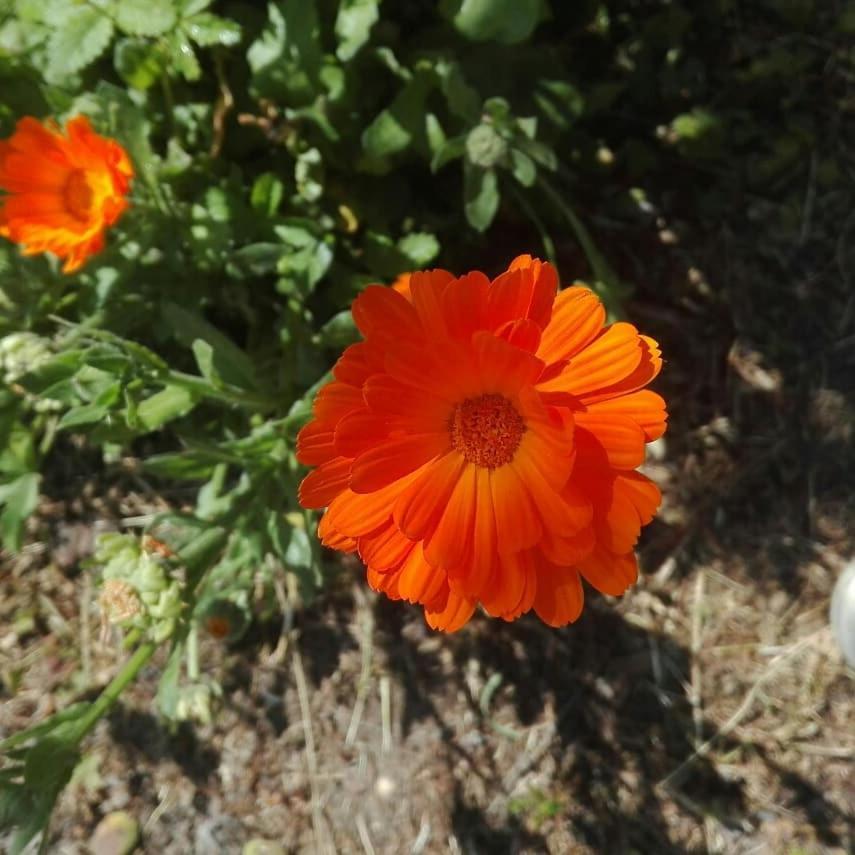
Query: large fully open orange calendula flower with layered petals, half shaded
[[297, 256, 666, 631]]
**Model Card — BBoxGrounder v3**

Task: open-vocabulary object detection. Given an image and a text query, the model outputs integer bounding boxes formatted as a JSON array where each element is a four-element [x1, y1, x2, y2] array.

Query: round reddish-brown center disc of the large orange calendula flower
[[450, 395, 525, 469]]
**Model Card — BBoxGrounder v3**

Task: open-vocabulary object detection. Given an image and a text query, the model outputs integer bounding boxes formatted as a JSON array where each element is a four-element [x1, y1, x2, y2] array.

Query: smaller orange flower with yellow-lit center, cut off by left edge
[[0, 116, 134, 273]]
